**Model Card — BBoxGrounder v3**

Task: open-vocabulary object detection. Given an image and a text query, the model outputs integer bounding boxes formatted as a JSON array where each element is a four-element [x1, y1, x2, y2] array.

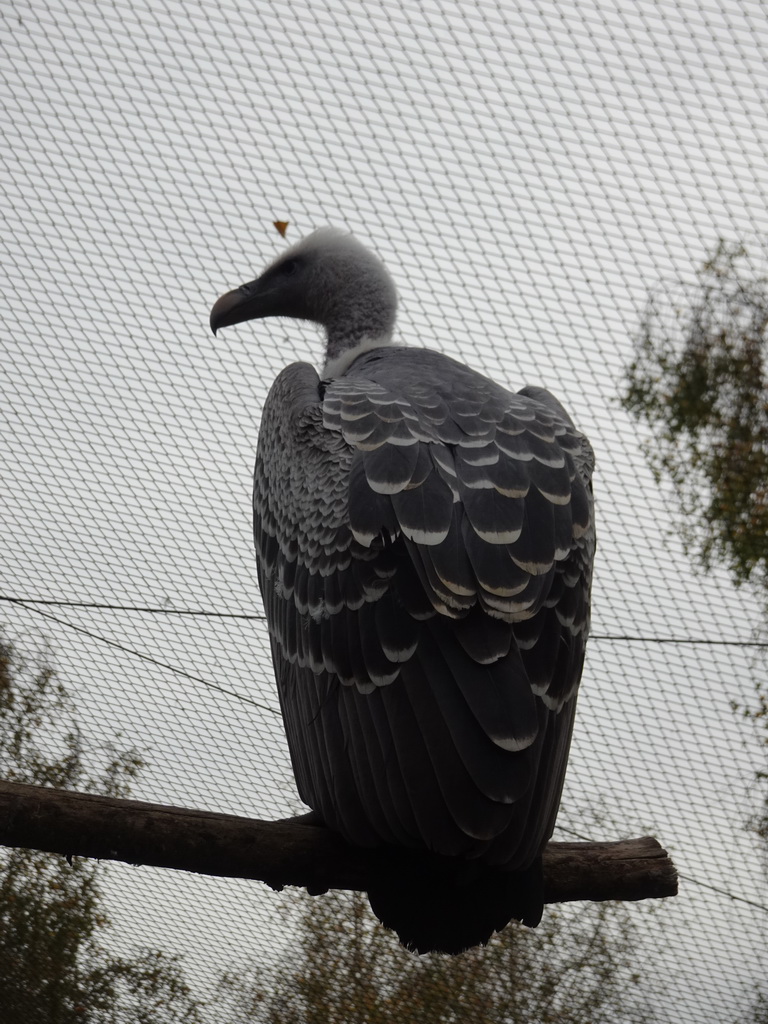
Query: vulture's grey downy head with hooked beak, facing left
[[211, 227, 397, 370]]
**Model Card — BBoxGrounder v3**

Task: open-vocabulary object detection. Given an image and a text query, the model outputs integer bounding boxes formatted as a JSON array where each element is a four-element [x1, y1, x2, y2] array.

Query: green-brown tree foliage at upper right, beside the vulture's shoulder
[[624, 242, 768, 590]]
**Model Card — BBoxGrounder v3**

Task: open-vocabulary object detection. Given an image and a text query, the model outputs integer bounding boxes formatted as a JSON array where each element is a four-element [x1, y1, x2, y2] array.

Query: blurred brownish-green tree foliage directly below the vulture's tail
[[218, 893, 650, 1024]]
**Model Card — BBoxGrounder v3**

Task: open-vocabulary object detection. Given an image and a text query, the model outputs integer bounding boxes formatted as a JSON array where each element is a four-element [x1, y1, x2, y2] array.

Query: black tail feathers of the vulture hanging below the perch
[[368, 857, 544, 953]]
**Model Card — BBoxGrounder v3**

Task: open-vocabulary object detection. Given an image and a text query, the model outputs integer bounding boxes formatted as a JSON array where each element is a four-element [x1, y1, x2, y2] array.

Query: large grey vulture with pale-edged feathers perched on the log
[[211, 227, 595, 953]]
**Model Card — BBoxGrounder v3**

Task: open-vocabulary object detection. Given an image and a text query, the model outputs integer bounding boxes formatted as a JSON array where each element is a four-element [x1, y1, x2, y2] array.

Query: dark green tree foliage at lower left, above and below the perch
[[0, 641, 202, 1024]]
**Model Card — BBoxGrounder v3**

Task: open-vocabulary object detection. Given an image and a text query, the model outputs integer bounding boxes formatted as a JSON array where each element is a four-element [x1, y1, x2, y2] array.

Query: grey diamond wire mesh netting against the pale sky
[[0, 0, 768, 1022]]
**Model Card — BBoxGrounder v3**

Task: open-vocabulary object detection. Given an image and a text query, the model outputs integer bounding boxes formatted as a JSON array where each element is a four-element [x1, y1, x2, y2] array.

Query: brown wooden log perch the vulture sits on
[[0, 782, 677, 903]]
